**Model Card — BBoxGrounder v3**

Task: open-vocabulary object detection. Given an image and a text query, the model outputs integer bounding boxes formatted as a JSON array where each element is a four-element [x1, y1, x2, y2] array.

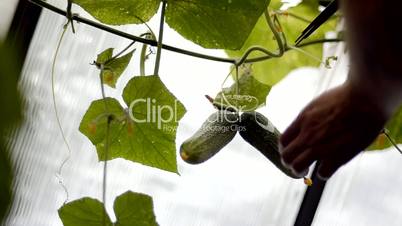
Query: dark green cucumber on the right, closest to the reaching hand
[[239, 111, 299, 179]]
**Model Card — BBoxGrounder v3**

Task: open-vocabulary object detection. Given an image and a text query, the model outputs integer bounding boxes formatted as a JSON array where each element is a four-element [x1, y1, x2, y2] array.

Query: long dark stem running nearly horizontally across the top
[[29, 0, 343, 64]]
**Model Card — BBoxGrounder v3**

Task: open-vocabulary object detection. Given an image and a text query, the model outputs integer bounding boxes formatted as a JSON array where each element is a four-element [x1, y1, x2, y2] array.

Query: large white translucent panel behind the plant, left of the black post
[[3, 1, 344, 226]]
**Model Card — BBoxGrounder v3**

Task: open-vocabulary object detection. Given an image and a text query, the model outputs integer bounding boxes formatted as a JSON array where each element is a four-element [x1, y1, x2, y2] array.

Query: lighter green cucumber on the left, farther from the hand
[[180, 110, 239, 164]]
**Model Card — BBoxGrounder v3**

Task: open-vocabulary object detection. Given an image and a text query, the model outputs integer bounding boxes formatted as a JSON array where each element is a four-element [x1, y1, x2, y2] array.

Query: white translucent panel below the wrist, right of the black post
[[313, 148, 402, 226]]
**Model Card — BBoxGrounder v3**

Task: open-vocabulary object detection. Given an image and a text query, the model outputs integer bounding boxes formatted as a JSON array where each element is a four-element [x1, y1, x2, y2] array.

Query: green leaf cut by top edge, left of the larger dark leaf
[[72, 0, 160, 25]]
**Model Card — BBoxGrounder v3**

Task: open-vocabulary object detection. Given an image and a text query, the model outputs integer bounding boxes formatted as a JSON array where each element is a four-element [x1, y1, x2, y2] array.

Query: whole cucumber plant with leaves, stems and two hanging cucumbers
[[25, 0, 402, 226]]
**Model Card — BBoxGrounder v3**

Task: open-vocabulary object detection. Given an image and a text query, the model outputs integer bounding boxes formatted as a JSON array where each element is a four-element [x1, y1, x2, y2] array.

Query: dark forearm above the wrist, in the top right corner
[[342, 0, 402, 117]]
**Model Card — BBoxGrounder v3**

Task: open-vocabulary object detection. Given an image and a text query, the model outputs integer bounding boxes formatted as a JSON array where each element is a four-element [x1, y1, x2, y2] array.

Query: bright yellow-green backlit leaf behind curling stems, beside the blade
[[226, 0, 335, 86]]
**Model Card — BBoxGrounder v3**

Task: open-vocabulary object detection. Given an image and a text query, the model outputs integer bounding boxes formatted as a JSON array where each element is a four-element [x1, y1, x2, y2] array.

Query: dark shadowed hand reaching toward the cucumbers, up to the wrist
[[280, 82, 387, 179]]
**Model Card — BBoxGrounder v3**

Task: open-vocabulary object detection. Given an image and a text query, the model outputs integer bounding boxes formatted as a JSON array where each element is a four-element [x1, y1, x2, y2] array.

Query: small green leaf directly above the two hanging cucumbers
[[214, 64, 271, 111]]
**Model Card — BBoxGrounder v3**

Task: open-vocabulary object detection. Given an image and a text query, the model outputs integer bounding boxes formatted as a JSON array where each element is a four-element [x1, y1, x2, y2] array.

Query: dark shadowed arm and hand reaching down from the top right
[[280, 0, 402, 178]]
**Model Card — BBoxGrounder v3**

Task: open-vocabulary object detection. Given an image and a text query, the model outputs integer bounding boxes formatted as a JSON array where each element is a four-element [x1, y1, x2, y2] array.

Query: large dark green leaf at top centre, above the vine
[[166, 0, 267, 49]]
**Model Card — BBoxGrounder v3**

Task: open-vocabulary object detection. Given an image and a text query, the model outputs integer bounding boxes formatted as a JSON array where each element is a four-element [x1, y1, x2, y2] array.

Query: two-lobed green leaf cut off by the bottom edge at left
[[59, 191, 158, 226]]
